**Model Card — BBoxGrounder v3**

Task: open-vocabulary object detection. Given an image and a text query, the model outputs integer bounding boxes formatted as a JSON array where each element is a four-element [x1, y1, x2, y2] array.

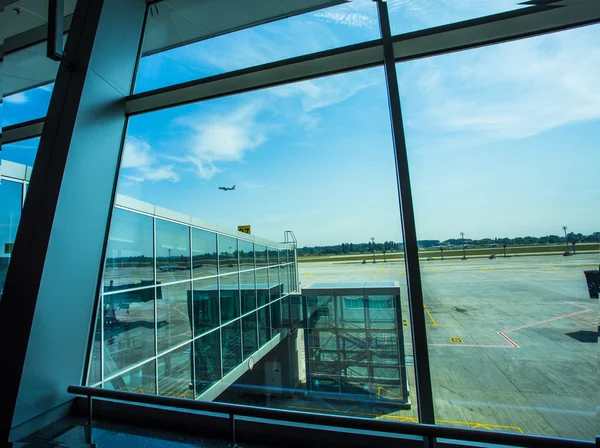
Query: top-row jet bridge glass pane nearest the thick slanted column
[[104, 208, 154, 292]]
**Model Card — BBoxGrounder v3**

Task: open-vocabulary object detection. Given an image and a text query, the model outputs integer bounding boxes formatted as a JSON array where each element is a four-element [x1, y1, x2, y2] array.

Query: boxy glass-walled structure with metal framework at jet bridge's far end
[[302, 282, 410, 408]]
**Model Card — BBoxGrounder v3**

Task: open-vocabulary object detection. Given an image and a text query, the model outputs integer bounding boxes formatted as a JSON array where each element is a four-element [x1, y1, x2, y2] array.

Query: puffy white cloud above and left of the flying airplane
[[176, 103, 266, 179]]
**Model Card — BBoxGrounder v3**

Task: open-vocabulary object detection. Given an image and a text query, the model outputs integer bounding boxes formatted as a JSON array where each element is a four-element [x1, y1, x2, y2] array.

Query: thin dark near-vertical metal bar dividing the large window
[[377, 0, 435, 424]]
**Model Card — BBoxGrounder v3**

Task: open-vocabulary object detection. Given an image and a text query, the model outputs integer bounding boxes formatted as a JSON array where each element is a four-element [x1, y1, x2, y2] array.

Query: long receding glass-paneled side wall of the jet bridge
[[88, 203, 298, 400]]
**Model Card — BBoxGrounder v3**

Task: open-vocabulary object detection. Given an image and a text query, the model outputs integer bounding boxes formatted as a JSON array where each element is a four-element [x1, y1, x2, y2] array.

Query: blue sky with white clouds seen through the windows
[[4, 0, 600, 246]]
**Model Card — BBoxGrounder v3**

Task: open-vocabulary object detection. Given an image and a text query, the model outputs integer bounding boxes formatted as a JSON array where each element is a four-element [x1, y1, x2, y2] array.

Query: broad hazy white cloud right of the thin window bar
[[399, 27, 600, 146]]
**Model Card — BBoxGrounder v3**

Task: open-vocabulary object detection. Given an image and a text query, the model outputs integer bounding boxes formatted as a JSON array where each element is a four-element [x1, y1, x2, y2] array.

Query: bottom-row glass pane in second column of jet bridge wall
[[158, 343, 194, 399]]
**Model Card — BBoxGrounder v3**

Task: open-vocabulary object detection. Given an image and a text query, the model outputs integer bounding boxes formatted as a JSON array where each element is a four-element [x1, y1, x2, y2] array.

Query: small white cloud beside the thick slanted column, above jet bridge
[[121, 137, 180, 182]]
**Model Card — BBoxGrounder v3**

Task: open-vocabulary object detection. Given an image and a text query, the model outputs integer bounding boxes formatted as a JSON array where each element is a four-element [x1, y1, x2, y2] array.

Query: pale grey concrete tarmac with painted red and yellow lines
[[299, 254, 599, 440]]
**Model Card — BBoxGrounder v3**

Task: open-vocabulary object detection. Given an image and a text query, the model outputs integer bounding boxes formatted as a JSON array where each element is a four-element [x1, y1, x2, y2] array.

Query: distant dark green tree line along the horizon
[[298, 232, 600, 256]]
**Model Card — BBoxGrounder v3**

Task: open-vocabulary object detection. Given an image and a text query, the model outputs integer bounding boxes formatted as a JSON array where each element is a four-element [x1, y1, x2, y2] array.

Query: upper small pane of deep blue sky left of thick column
[[2, 83, 54, 127]]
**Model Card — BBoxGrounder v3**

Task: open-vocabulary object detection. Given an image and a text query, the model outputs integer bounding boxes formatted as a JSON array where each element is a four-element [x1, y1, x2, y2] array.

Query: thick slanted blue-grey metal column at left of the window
[[0, 0, 146, 445]]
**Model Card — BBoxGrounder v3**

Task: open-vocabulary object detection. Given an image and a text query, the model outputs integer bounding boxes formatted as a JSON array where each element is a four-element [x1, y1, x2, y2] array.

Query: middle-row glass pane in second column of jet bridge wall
[[156, 282, 192, 352]]
